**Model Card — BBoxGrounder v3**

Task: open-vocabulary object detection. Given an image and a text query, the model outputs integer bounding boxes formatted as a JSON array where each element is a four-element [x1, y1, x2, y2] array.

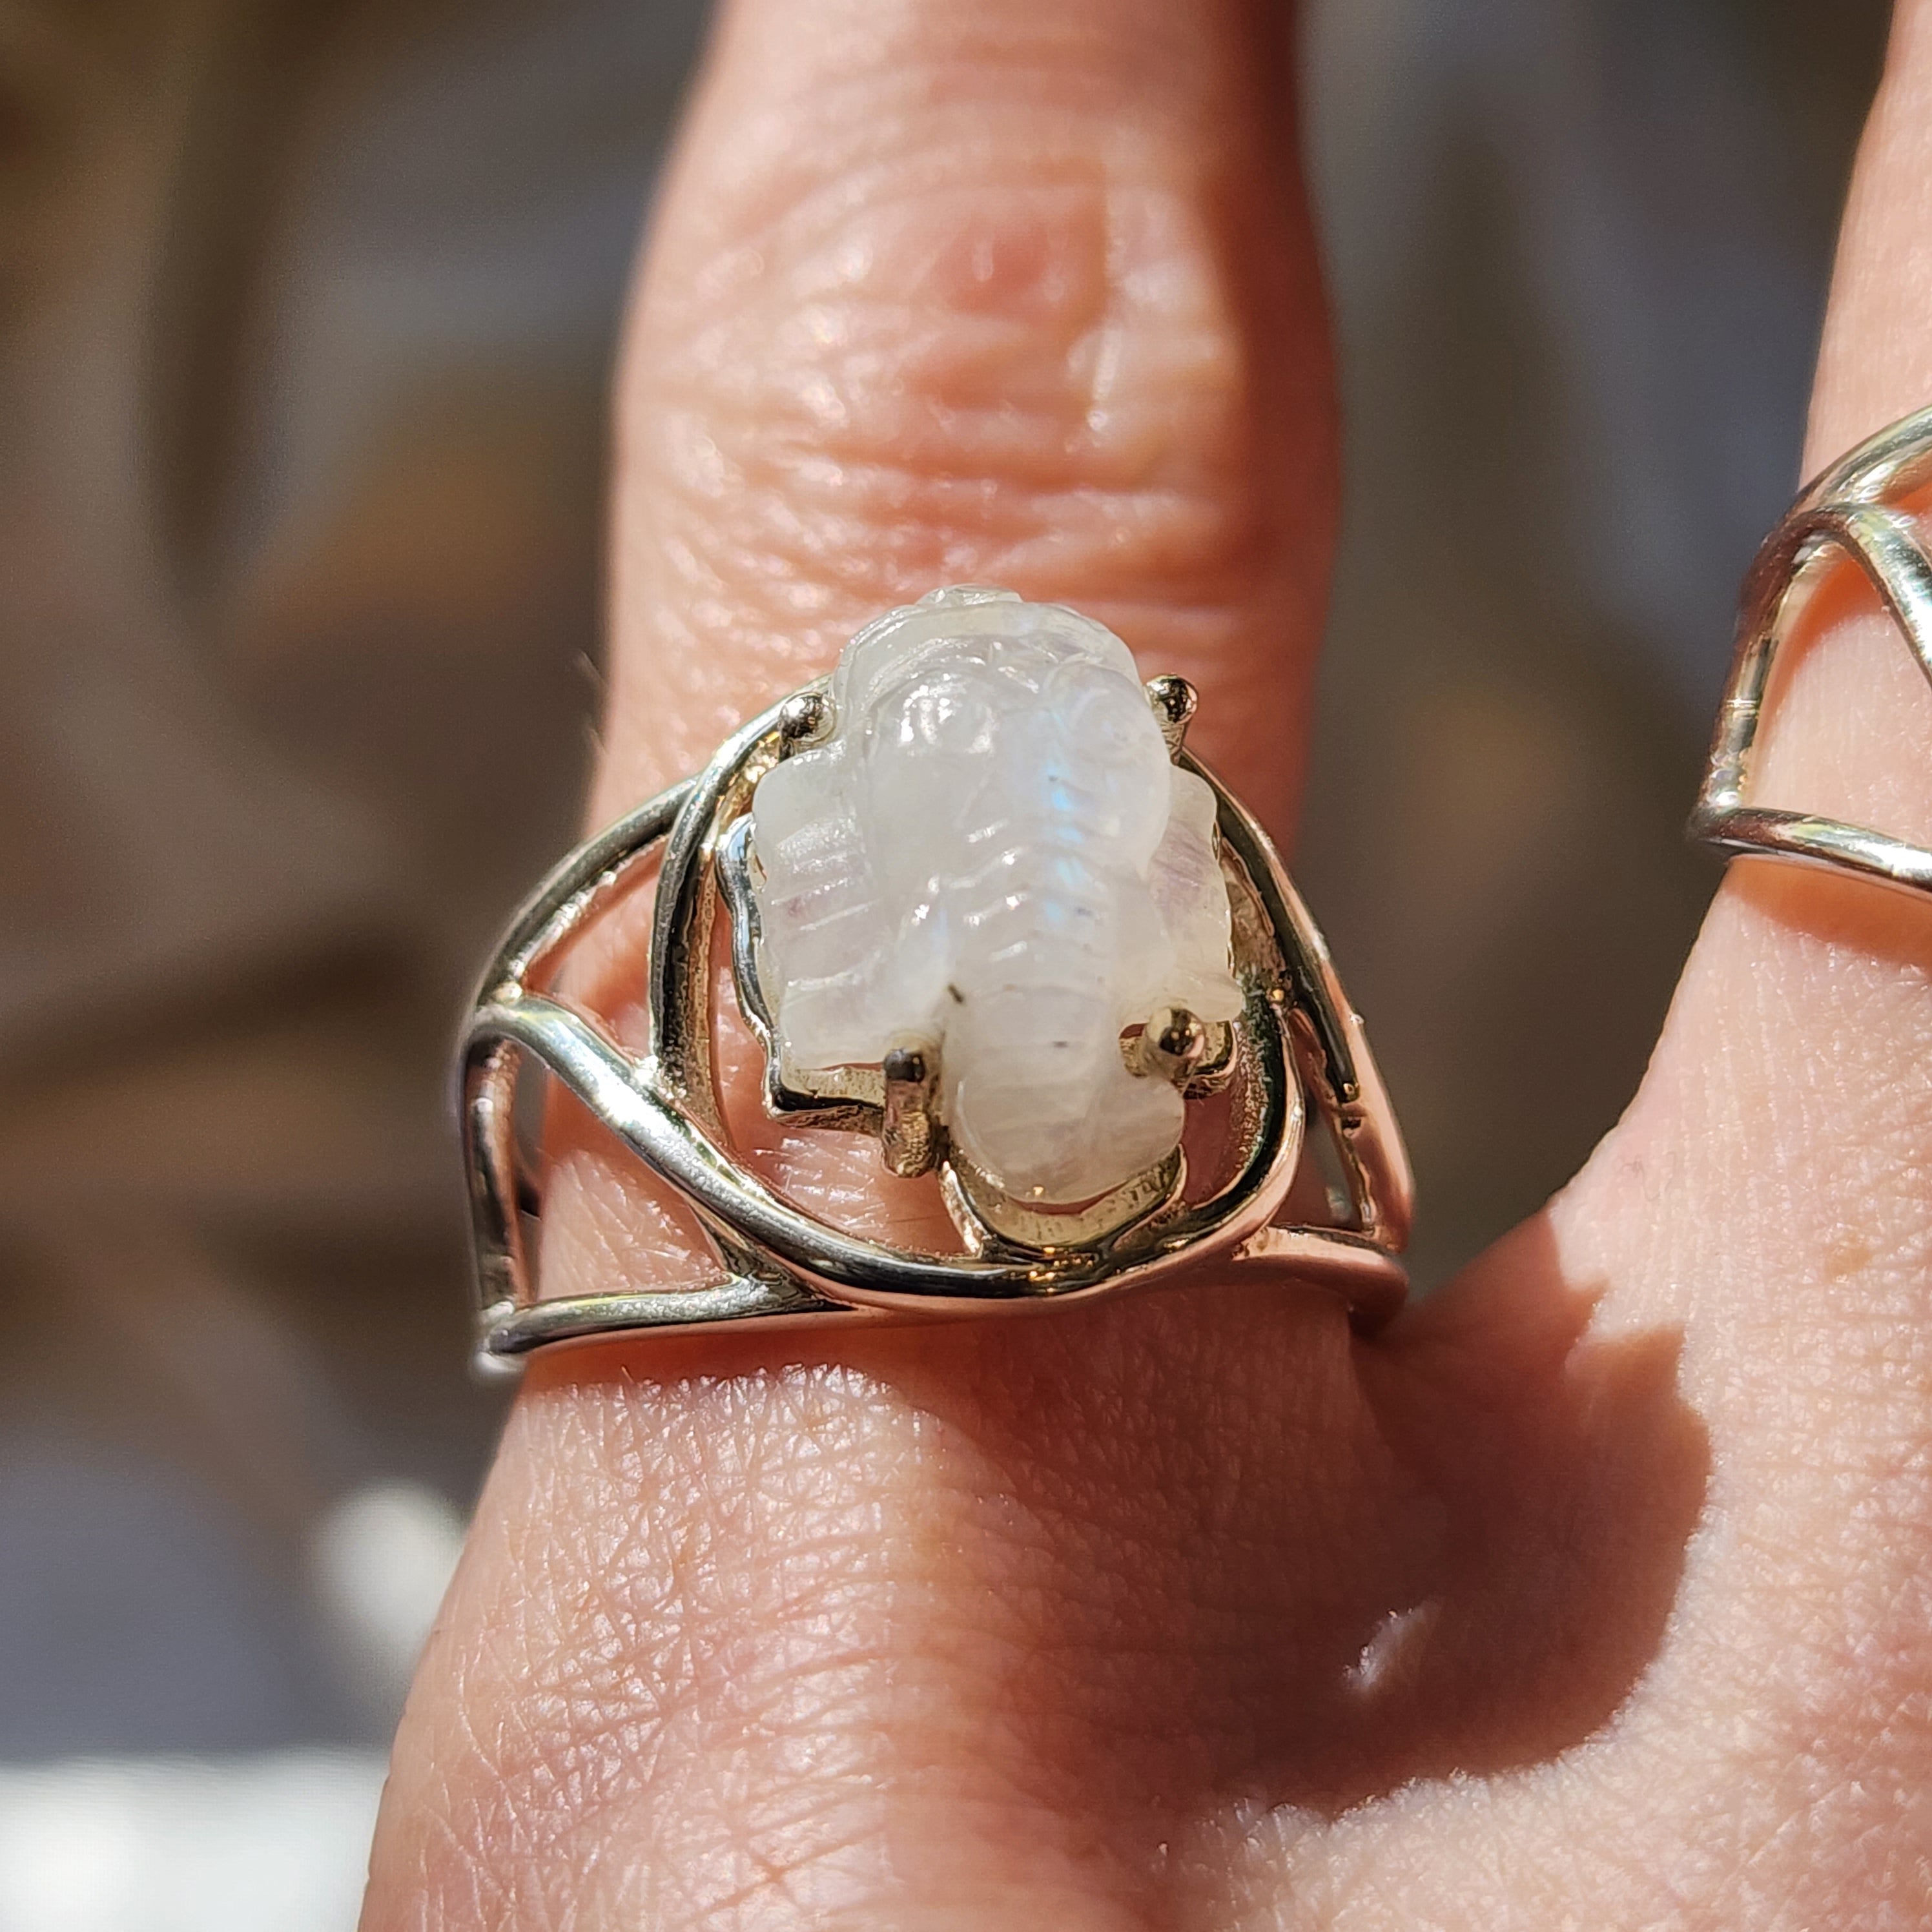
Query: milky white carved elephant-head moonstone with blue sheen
[[752, 590, 1240, 1204]]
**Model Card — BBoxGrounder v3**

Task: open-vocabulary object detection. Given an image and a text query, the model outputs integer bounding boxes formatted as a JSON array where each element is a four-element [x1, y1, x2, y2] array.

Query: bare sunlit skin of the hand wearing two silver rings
[[363, 0, 1932, 1932]]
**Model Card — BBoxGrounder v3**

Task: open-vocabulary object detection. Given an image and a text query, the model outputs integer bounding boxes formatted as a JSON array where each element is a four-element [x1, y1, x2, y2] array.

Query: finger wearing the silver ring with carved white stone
[[367, 0, 1393, 1928]]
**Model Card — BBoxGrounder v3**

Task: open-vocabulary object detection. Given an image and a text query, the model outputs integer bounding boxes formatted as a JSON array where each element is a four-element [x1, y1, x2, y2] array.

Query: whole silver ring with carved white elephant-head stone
[[458, 588, 1412, 1368]]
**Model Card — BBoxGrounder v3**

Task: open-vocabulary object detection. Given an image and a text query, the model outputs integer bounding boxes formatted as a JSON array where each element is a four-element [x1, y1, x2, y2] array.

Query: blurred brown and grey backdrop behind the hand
[[0, 0, 1886, 1932]]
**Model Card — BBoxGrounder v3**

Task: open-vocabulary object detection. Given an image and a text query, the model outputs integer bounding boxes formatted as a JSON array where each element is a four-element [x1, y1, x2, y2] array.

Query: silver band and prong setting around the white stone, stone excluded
[[458, 590, 1412, 1370]]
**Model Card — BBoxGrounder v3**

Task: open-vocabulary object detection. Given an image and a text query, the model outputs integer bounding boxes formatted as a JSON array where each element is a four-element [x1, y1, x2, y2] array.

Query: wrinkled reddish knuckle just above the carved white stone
[[622, 107, 1298, 630]]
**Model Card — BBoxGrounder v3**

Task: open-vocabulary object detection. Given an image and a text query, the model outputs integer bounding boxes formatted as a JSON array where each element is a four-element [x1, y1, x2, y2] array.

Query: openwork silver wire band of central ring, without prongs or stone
[[460, 653, 1410, 1370]]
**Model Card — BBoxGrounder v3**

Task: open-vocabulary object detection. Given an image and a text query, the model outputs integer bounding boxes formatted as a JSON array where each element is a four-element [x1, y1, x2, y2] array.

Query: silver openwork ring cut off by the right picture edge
[[1689, 409, 1932, 892]]
